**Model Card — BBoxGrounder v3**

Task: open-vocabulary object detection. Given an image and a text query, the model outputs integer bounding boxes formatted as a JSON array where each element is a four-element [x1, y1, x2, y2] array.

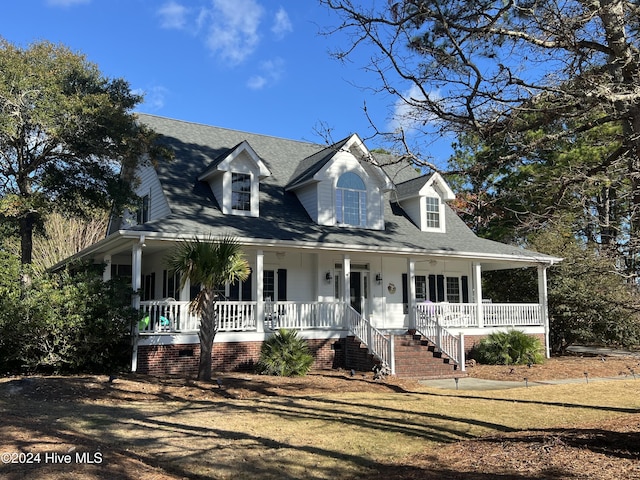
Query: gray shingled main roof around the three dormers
[[134, 114, 552, 261]]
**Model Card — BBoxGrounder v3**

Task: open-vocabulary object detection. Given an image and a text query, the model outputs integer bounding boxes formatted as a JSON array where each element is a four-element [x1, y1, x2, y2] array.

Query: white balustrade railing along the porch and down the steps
[[134, 299, 546, 374]]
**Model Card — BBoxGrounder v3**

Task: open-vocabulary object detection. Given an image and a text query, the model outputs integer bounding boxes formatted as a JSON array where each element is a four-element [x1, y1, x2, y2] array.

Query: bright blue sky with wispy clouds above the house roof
[[5, 0, 456, 165]]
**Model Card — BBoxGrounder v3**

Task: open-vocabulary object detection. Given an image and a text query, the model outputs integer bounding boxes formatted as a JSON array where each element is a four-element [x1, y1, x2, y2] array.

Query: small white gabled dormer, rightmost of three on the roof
[[396, 173, 455, 233]]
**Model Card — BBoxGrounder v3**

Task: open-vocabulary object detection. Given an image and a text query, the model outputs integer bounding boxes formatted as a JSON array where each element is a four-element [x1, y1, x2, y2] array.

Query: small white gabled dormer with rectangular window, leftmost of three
[[198, 141, 271, 217]]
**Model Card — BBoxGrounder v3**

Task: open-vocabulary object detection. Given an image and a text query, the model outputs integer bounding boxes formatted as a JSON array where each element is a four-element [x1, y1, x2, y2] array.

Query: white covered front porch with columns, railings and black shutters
[[75, 232, 552, 373]]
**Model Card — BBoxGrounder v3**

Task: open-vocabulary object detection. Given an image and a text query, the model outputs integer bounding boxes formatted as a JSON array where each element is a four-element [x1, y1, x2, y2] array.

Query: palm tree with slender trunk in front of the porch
[[167, 237, 250, 380]]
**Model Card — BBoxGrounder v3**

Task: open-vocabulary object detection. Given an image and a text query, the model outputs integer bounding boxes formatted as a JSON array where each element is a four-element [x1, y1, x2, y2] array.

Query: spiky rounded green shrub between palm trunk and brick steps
[[258, 329, 313, 377]]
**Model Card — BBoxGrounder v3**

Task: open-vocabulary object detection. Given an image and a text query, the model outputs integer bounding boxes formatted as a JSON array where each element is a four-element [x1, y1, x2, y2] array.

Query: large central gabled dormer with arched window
[[285, 134, 393, 230]]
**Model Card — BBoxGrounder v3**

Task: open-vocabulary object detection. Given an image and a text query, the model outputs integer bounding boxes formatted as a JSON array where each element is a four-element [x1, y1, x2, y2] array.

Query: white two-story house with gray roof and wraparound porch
[[66, 114, 560, 377]]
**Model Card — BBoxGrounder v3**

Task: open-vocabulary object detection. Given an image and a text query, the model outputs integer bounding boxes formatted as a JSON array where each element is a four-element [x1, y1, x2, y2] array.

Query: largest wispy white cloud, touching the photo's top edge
[[207, 0, 264, 65]]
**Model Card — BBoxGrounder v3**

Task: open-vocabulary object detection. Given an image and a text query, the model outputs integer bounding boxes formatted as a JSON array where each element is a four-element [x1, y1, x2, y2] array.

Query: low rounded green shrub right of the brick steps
[[471, 330, 544, 365]]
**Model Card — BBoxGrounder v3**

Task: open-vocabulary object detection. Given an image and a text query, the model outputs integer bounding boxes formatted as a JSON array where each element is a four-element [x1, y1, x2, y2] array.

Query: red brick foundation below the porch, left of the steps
[[137, 338, 345, 377]]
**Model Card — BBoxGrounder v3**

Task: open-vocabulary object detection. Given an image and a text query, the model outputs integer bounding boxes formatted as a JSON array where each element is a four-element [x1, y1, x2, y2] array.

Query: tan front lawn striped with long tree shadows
[[0, 358, 640, 480]]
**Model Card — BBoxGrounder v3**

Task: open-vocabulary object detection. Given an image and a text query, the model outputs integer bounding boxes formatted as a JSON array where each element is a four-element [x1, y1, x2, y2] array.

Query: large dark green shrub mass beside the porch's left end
[[0, 256, 137, 374]]
